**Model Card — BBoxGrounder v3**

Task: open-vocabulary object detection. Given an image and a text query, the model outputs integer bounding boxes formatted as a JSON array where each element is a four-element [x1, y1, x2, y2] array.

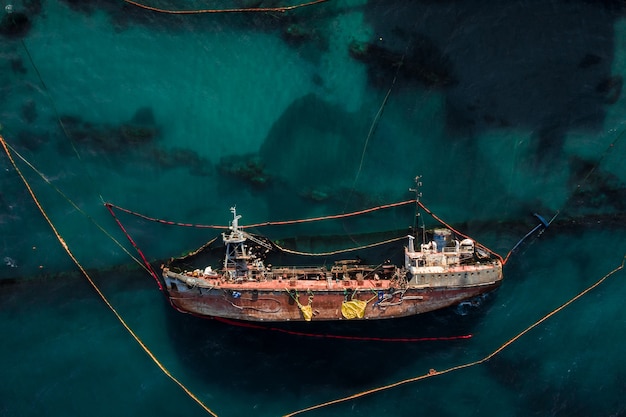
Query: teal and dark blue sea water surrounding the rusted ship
[[0, 0, 626, 416]]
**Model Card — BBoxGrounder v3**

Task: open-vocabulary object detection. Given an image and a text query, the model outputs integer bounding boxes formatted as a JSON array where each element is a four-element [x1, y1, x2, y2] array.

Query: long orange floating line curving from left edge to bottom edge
[[0, 135, 217, 417]]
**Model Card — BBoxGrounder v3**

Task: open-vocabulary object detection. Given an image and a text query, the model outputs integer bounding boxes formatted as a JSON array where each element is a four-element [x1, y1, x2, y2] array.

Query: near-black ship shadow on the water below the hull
[[165, 291, 497, 395]]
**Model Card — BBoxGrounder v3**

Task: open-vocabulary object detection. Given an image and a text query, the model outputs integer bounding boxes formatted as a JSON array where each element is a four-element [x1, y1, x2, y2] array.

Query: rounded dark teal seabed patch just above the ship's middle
[[254, 94, 367, 207]]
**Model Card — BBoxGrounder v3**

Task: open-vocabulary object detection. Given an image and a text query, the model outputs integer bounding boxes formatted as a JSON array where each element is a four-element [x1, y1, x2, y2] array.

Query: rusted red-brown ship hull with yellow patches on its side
[[164, 264, 502, 322]]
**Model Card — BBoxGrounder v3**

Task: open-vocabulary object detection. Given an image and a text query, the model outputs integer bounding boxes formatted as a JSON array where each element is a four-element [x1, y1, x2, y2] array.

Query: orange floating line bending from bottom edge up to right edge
[[283, 254, 626, 417]]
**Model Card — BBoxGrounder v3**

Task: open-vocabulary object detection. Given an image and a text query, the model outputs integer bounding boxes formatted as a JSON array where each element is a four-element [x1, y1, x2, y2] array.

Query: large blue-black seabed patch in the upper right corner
[[366, 1, 621, 159]]
